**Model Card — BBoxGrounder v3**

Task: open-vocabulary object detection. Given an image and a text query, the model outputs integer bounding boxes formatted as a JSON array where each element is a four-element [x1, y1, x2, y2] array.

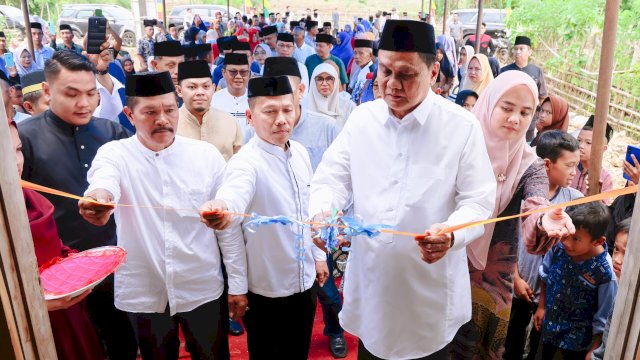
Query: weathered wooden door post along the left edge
[[0, 85, 57, 360]]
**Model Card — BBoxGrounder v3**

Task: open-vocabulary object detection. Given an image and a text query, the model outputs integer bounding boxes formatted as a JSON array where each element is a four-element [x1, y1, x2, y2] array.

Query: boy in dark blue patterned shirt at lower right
[[534, 202, 618, 360]]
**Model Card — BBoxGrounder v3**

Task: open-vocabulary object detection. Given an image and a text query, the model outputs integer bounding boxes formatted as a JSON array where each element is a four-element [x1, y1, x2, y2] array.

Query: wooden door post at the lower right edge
[[604, 187, 640, 360]]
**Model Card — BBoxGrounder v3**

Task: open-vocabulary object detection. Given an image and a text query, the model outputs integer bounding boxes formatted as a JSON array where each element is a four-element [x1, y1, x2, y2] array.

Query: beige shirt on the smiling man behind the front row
[[177, 105, 244, 161]]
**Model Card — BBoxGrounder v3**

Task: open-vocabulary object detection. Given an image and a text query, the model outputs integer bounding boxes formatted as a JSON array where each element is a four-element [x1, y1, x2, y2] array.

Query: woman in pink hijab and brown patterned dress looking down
[[451, 72, 575, 359]]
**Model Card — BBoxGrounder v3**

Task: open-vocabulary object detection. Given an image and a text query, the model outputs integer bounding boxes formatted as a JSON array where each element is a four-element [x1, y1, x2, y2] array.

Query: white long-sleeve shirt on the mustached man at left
[[86, 136, 247, 315]]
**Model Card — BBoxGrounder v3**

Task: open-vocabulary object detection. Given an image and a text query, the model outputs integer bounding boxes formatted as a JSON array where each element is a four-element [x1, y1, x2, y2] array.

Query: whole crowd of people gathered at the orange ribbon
[[0, 7, 640, 360]]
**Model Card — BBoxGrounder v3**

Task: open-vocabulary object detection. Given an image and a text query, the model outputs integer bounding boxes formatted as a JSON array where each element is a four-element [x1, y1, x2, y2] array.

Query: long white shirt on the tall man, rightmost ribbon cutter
[[309, 92, 496, 359]]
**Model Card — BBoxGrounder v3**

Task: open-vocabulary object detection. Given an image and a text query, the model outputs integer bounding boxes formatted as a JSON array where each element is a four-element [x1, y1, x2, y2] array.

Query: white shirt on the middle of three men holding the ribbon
[[216, 136, 326, 298]]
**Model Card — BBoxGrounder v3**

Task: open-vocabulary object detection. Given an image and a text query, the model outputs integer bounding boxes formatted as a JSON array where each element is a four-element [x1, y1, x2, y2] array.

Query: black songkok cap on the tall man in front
[[379, 20, 436, 55]]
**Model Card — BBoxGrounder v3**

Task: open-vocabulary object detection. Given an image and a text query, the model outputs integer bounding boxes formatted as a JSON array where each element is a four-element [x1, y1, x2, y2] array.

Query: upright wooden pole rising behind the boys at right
[[588, 0, 620, 195]]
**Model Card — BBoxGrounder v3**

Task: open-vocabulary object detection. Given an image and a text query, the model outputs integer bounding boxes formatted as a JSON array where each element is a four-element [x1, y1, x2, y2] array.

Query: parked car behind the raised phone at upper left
[[58, 4, 136, 47]]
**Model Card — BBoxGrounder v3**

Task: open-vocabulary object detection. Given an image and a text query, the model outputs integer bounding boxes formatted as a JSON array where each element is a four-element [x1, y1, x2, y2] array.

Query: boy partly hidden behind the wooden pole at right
[[571, 115, 613, 200]]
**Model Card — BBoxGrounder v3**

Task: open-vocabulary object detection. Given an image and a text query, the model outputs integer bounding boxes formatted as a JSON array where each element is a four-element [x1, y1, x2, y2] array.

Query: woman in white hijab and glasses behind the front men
[[304, 63, 356, 129]]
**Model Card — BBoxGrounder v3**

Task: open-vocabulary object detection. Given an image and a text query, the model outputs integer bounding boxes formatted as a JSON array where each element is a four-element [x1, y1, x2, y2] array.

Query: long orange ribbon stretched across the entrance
[[21, 180, 638, 237]]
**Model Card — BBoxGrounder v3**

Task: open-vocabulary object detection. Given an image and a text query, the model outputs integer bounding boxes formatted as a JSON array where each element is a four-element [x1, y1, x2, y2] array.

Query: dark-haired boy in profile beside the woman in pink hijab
[[504, 130, 583, 360]]
